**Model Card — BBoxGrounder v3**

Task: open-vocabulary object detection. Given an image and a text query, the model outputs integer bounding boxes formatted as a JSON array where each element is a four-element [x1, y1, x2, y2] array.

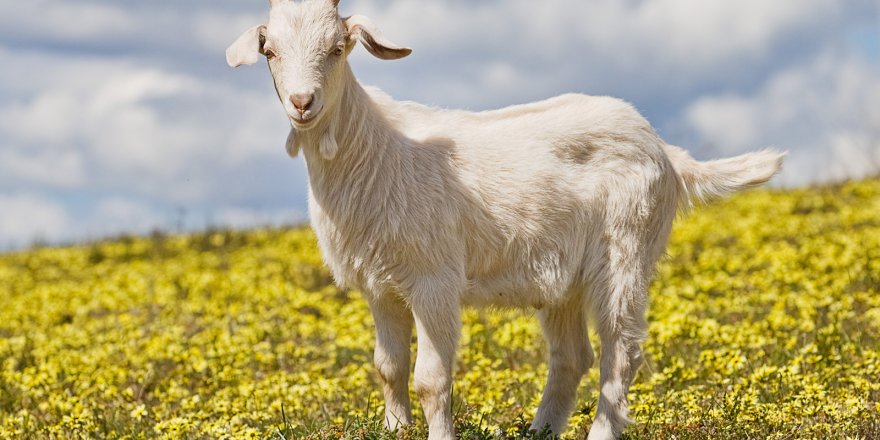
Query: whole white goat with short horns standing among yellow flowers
[[227, 0, 783, 439]]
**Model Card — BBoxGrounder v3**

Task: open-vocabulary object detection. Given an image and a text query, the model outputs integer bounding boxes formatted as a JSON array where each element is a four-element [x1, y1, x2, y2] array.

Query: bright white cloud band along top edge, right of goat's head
[[341, 0, 869, 66]]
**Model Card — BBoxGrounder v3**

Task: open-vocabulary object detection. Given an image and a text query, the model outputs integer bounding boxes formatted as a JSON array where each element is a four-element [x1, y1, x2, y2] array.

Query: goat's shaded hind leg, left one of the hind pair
[[531, 292, 593, 435]]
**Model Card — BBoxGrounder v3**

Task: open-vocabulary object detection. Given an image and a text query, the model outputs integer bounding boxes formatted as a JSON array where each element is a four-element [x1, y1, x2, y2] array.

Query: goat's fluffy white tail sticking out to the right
[[665, 145, 786, 206]]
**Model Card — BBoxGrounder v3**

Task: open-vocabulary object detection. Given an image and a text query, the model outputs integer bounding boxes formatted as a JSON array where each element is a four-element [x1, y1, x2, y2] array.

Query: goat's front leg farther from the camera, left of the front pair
[[369, 295, 413, 431]]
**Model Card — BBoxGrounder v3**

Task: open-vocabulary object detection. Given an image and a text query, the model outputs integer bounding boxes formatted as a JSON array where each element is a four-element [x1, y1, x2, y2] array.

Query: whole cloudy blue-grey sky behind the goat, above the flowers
[[0, 0, 880, 249]]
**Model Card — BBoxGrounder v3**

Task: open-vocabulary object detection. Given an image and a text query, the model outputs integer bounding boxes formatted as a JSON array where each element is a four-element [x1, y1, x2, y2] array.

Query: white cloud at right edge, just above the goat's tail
[[684, 54, 880, 185]]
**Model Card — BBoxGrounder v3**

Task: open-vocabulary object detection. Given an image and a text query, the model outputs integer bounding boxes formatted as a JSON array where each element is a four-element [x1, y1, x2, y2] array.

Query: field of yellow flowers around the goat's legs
[[0, 180, 880, 439]]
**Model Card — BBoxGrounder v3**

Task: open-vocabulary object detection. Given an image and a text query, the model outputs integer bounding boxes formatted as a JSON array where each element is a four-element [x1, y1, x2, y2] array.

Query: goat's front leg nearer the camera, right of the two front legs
[[411, 280, 461, 440]]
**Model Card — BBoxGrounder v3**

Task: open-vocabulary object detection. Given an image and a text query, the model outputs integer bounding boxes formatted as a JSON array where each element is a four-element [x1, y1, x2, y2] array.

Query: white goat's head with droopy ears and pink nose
[[226, 0, 411, 130]]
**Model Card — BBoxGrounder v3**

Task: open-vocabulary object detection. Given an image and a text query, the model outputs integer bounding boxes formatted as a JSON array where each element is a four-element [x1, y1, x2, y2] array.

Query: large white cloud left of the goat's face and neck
[[0, 44, 286, 203]]
